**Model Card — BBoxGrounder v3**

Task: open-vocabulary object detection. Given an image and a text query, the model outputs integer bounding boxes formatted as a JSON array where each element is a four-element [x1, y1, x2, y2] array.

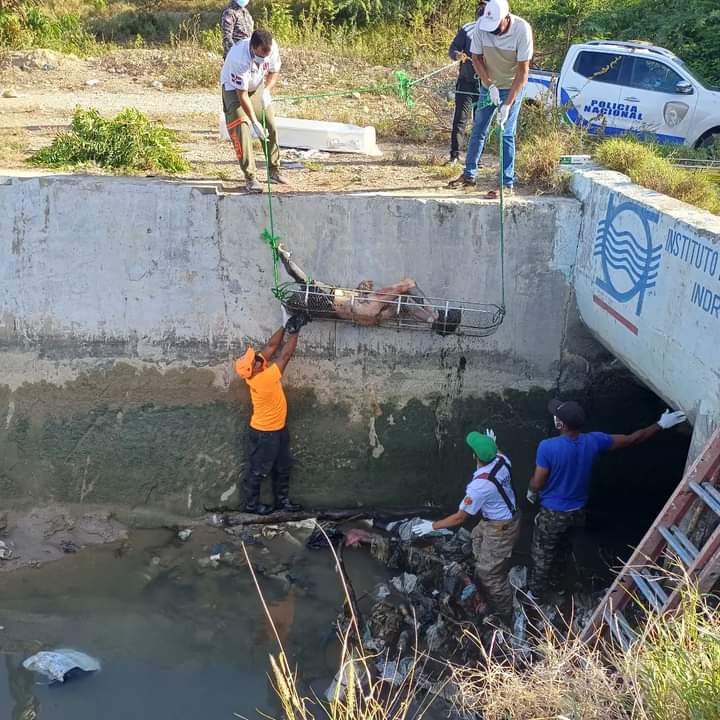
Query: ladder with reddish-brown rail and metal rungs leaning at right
[[581, 428, 720, 649]]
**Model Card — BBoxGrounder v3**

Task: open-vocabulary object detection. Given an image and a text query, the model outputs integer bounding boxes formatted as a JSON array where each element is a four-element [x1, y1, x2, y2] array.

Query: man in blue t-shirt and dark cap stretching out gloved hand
[[527, 400, 687, 600]]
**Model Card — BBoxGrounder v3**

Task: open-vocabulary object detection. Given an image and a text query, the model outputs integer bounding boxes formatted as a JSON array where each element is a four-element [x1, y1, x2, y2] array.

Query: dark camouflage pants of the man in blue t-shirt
[[529, 507, 585, 598]]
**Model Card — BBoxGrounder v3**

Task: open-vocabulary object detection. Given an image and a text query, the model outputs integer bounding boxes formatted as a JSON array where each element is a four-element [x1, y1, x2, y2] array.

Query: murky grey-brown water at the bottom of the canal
[[0, 530, 385, 720]]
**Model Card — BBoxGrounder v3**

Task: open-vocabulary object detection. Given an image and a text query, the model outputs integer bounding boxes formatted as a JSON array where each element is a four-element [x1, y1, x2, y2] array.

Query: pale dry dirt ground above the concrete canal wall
[[0, 48, 506, 195]]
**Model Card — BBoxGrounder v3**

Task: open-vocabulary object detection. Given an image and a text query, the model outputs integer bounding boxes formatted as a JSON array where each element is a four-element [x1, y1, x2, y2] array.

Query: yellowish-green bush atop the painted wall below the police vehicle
[[595, 138, 720, 214]]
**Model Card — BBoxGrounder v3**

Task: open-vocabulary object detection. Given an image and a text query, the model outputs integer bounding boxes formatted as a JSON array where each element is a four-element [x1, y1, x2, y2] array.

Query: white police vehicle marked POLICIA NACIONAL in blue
[[526, 40, 720, 147]]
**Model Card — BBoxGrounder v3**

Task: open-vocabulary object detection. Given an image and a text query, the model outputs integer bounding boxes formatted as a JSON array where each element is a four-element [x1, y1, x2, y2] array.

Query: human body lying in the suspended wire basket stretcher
[[278, 244, 462, 335]]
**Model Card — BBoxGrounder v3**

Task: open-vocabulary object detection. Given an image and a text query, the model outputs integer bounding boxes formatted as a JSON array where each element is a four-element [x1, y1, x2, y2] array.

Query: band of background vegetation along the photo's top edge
[[0, 0, 720, 83]]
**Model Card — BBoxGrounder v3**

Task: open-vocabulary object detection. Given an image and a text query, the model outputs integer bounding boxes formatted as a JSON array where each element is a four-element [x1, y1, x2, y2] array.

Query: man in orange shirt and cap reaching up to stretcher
[[235, 315, 307, 515]]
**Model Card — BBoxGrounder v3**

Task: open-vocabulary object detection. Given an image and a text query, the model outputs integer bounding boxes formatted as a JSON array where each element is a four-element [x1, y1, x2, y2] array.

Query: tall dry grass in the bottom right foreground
[[243, 512, 720, 720]]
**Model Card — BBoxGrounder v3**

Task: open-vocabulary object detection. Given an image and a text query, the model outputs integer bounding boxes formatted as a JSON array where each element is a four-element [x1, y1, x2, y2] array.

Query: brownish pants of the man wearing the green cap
[[472, 515, 520, 615]]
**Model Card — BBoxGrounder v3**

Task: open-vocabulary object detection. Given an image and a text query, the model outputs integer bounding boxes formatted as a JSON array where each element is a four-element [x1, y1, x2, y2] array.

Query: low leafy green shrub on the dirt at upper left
[[29, 108, 190, 173]]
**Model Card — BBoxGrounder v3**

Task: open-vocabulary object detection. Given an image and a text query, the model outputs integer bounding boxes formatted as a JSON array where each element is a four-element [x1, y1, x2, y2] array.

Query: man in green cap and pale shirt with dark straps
[[413, 430, 520, 622]]
